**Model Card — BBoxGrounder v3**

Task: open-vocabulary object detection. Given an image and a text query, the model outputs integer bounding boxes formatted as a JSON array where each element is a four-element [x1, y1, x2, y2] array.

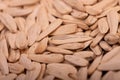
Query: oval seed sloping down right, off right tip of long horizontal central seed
[[65, 55, 88, 66]]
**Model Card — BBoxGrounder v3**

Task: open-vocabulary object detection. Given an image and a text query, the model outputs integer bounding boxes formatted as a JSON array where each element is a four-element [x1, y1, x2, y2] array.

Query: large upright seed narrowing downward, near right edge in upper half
[[107, 10, 119, 34]]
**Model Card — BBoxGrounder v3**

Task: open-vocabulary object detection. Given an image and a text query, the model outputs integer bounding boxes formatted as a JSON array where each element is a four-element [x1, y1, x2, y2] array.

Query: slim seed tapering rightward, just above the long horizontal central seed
[[47, 46, 73, 54]]
